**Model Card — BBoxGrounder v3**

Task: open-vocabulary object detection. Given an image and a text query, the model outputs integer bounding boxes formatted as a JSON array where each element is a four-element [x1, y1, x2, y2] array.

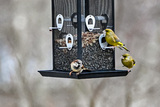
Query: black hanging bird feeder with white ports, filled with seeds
[[39, 0, 128, 79]]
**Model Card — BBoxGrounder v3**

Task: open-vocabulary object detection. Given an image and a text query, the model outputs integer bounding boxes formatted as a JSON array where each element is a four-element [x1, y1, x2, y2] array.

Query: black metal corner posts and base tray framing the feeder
[[38, 0, 128, 79]]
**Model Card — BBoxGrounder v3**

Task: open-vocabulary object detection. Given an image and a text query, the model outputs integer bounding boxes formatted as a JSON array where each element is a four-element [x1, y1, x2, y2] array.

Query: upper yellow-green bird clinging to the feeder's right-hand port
[[104, 29, 129, 52]]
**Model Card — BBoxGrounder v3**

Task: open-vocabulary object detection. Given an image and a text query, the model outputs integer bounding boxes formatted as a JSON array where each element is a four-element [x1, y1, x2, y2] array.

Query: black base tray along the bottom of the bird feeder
[[38, 70, 128, 79]]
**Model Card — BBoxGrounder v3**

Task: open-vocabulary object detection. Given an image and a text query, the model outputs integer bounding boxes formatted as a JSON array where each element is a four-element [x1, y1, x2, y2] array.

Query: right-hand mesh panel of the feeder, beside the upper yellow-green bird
[[82, 0, 114, 70]]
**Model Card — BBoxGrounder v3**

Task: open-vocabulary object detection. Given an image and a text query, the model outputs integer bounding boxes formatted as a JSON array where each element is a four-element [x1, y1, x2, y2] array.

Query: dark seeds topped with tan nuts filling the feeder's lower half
[[54, 32, 114, 71]]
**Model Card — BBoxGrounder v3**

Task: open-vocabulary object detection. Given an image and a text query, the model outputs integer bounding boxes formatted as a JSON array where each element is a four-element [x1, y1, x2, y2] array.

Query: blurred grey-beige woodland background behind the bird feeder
[[0, 0, 160, 107]]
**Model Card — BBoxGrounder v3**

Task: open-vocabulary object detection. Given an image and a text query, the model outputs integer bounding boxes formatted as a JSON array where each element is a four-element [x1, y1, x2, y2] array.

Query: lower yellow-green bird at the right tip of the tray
[[121, 53, 136, 72]]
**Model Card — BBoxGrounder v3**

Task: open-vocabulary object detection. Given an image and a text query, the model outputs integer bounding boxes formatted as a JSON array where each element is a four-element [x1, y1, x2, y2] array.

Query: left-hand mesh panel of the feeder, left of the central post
[[54, 0, 77, 71]]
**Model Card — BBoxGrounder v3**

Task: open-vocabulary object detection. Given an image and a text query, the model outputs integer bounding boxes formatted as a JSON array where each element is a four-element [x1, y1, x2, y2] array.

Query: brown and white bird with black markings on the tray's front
[[69, 59, 85, 76]]
